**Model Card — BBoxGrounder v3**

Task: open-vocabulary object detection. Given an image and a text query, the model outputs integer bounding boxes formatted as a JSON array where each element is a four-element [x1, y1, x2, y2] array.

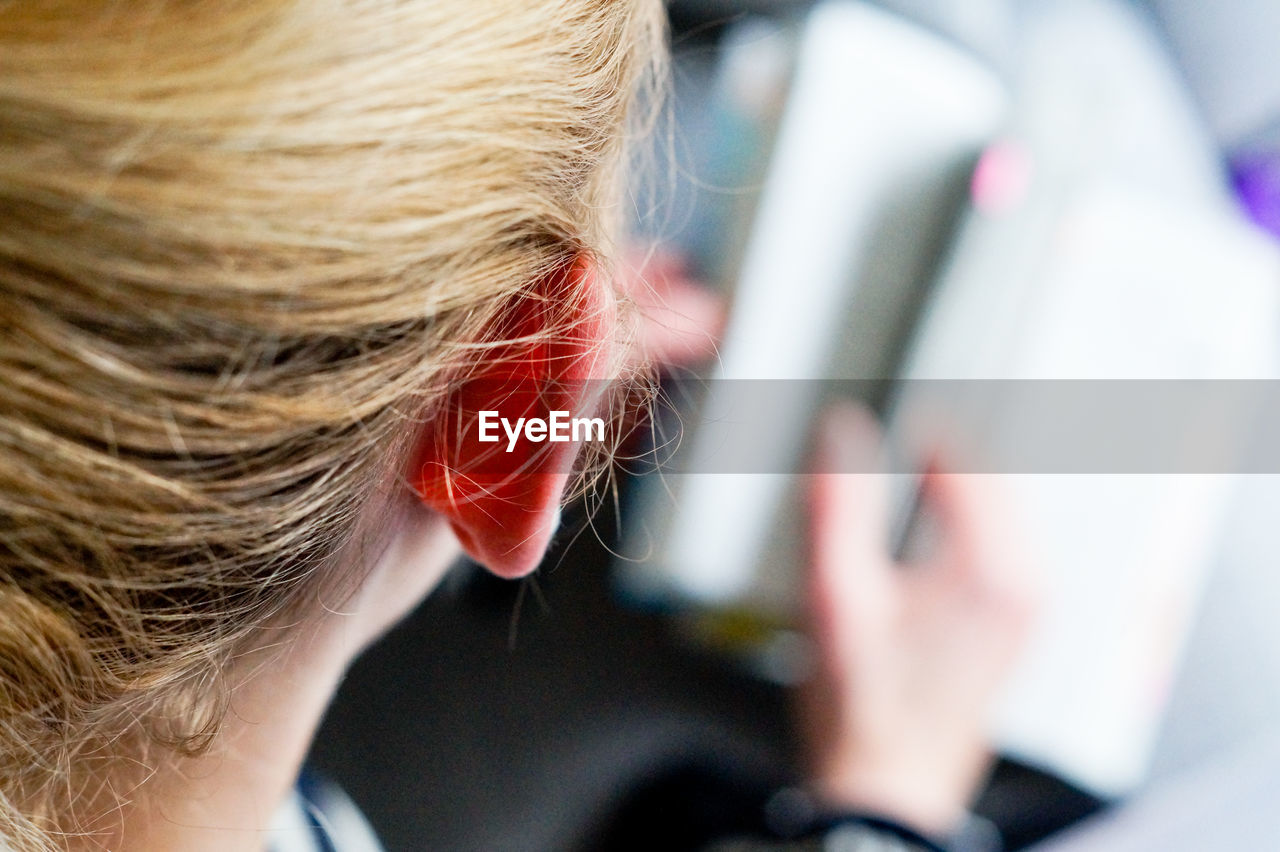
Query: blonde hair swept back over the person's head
[[0, 0, 662, 852]]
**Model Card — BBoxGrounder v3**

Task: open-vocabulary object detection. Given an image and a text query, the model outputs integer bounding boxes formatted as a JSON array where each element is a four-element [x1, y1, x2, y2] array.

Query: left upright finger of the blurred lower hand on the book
[[808, 404, 892, 654]]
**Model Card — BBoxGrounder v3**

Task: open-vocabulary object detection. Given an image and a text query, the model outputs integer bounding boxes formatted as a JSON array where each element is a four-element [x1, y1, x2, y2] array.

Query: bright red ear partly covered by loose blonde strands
[[415, 258, 616, 578]]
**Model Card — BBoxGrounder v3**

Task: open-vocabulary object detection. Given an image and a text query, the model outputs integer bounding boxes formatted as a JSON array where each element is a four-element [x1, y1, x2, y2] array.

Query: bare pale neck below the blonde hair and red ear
[[76, 504, 458, 852]]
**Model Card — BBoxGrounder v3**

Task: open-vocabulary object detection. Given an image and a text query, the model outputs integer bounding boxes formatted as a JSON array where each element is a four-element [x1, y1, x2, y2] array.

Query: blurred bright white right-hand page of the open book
[[908, 185, 1280, 793]]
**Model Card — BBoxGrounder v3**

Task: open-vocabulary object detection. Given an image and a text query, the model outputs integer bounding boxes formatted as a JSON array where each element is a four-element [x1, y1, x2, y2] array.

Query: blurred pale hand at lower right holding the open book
[[799, 406, 1036, 835]]
